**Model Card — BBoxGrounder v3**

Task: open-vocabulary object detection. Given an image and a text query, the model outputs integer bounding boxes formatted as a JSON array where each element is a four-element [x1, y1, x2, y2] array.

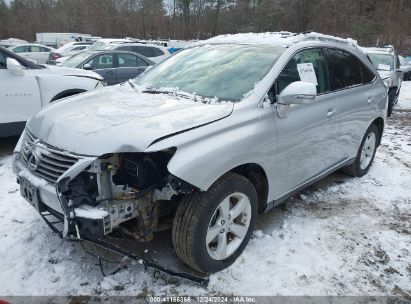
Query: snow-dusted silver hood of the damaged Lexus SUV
[[27, 84, 234, 156]]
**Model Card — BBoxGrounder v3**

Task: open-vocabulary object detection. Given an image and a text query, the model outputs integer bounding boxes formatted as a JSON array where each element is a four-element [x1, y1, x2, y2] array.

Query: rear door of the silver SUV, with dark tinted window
[[324, 48, 381, 159]]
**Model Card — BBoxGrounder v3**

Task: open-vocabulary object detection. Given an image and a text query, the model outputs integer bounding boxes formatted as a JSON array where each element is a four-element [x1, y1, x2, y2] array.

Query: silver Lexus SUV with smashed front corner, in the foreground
[[14, 33, 388, 273]]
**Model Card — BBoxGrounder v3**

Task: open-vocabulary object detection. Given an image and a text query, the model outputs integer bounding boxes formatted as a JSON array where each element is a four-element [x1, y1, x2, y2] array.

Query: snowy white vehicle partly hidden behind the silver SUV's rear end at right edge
[[364, 47, 403, 116]]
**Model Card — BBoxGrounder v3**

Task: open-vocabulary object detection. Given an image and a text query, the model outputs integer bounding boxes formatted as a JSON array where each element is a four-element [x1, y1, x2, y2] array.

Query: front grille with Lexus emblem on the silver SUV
[[21, 130, 81, 184]]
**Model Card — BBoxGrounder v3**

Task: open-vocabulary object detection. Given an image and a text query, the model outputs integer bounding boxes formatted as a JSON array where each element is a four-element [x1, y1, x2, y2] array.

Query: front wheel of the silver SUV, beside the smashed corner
[[172, 173, 258, 273]]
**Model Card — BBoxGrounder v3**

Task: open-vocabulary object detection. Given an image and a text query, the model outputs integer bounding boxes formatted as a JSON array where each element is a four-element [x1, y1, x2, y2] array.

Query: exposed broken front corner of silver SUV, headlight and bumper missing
[[56, 148, 197, 242]]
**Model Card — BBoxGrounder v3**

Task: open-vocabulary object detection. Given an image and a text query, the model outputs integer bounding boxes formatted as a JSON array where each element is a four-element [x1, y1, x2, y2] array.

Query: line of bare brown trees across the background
[[0, 0, 411, 51]]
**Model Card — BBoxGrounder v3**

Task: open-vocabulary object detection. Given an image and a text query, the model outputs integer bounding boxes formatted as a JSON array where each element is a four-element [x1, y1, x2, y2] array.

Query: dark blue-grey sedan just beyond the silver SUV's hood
[[62, 51, 154, 85]]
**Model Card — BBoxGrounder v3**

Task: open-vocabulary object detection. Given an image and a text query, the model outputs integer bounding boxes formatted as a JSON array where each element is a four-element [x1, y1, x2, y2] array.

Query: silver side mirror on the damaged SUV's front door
[[278, 81, 317, 105]]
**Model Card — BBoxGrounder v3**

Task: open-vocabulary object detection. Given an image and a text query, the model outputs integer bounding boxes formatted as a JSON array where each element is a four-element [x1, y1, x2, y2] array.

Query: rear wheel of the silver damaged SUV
[[342, 124, 380, 177]]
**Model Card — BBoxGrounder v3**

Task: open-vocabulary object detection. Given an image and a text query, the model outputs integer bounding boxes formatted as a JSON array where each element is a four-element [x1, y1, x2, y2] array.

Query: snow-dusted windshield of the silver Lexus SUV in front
[[135, 45, 285, 101]]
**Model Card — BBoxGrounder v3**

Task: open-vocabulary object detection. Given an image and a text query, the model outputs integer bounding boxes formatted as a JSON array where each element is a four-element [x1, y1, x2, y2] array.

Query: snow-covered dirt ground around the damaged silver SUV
[[0, 82, 411, 297]]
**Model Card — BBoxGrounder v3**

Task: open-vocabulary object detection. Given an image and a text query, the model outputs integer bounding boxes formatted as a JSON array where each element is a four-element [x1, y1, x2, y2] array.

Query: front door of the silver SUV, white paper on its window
[[269, 48, 338, 198]]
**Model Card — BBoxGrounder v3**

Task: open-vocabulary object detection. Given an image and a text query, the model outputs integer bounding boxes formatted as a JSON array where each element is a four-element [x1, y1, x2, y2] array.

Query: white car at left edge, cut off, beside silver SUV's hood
[[0, 47, 102, 137]]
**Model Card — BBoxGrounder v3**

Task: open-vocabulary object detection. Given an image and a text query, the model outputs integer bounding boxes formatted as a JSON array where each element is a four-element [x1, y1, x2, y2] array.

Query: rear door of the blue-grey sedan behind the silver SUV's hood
[[117, 53, 148, 83]]
